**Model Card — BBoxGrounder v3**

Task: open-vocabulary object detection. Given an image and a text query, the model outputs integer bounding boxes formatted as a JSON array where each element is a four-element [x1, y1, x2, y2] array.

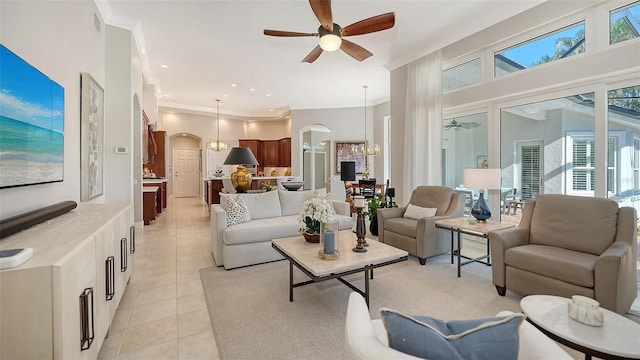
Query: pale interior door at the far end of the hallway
[[173, 148, 198, 197]]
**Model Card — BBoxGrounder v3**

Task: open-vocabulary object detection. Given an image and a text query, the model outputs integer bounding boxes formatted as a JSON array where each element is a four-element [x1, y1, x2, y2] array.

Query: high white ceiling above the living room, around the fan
[[97, 0, 545, 119]]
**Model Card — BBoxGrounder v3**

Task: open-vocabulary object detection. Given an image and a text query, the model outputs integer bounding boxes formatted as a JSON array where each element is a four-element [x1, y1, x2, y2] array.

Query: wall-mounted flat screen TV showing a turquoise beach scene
[[0, 45, 64, 189]]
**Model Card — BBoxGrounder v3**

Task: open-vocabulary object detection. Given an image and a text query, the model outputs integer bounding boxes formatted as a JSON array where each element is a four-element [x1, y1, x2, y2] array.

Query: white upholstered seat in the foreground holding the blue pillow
[[344, 292, 573, 360]]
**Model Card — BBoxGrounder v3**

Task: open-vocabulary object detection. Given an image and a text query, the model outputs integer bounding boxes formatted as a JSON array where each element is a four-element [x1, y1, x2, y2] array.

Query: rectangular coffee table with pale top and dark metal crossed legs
[[271, 230, 409, 306]]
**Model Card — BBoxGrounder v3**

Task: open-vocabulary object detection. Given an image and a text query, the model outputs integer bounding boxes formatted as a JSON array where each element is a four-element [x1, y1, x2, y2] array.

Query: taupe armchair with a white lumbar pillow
[[377, 186, 465, 265]]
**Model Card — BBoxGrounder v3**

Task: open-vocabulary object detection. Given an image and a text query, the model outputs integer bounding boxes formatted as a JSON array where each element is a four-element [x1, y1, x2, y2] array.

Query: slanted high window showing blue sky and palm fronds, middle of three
[[494, 22, 585, 77]]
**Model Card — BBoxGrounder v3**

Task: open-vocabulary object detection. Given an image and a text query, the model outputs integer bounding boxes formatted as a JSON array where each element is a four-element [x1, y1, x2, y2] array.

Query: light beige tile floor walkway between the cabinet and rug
[[99, 198, 219, 359]]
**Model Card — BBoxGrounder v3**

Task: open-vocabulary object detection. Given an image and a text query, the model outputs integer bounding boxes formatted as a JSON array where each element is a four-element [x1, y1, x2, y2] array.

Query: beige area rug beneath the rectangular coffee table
[[200, 255, 521, 360]]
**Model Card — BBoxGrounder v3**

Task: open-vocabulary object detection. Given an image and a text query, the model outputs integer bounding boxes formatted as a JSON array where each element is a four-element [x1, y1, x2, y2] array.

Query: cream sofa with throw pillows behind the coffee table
[[211, 189, 353, 270]]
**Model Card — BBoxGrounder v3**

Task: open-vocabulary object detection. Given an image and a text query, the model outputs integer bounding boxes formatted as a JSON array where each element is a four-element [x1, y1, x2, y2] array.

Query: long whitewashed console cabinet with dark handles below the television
[[0, 204, 135, 359]]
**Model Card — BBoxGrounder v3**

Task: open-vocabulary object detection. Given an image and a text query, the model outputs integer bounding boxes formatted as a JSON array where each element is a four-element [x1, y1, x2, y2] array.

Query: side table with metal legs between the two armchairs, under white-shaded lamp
[[436, 217, 515, 277]]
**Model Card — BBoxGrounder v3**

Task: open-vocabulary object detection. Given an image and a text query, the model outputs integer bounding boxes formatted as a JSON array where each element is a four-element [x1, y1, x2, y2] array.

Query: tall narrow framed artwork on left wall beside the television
[[80, 73, 104, 201]]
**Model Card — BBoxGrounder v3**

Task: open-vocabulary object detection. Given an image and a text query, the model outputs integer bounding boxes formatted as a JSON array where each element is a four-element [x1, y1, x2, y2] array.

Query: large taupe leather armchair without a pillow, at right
[[489, 194, 638, 314]]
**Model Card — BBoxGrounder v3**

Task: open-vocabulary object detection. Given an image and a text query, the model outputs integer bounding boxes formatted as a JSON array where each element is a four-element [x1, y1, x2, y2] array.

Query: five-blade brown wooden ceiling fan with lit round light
[[264, 0, 395, 63]]
